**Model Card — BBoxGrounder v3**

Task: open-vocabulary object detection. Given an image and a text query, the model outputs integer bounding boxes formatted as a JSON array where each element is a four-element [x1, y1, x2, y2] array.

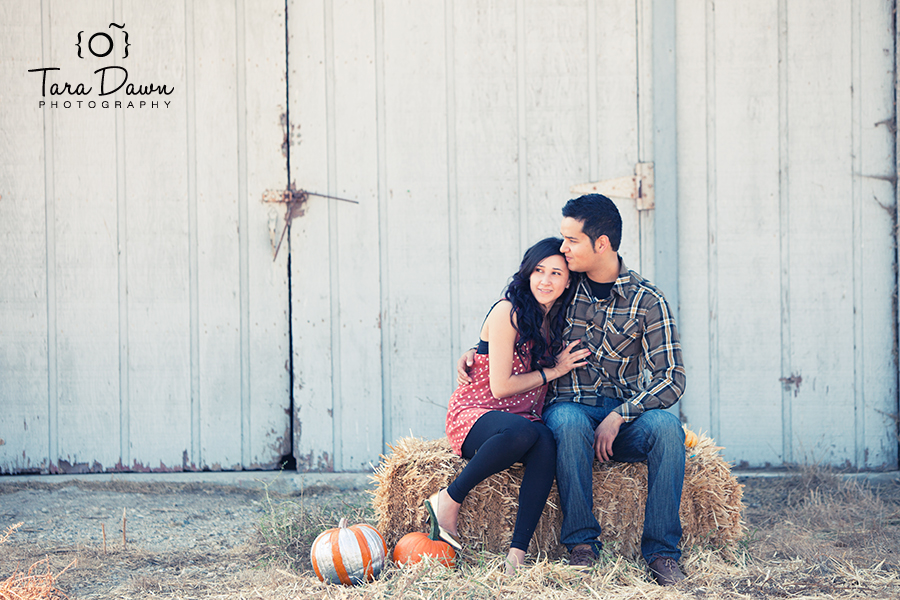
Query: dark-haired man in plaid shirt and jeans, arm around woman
[[459, 194, 685, 585]]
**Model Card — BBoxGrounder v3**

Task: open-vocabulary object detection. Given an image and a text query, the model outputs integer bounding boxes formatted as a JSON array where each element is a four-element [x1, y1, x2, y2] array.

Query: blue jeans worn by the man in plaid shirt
[[543, 398, 684, 564]]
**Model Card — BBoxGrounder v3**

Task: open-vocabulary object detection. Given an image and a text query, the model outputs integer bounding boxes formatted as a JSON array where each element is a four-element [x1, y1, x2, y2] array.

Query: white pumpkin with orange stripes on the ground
[[309, 519, 387, 585]]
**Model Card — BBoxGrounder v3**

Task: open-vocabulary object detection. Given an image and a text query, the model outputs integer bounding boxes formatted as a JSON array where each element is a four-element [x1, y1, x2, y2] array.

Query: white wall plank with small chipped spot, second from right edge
[[787, 2, 855, 464]]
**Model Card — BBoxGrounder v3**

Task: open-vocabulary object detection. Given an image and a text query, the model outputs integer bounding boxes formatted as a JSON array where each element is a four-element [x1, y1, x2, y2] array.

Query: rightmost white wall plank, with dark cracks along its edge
[[853, 2, 898, 469]]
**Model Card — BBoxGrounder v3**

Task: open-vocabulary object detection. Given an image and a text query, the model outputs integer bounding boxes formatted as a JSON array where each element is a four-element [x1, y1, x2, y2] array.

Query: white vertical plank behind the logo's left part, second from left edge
[[48, 1, 123, 472]]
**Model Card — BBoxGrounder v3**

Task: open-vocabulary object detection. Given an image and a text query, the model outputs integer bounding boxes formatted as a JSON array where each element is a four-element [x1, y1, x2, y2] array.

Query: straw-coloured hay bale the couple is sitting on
[[372, 435, 744, 559]]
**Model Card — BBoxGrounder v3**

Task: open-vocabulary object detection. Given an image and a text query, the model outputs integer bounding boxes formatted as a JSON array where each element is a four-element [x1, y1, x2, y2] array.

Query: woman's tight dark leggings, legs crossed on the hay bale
[[447, 410, 556, 551]]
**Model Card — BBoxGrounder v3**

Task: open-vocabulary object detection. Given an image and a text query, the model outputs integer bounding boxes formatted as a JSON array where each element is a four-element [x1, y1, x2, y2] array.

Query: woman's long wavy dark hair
[[504, 237, 574, 369]]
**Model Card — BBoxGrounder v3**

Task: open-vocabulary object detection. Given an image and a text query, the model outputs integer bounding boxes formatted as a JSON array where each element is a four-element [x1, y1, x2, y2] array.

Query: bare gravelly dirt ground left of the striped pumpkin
[[0, 477, 369, 599]]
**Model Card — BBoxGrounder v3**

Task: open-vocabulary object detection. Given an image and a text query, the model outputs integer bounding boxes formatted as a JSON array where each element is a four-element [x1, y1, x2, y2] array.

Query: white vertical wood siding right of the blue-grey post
[[678, 0, 897, 469]]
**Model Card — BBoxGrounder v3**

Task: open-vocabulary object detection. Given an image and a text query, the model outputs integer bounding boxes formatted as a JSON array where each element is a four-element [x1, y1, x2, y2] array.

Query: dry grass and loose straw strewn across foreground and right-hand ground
[[0, 469, 900, 600]]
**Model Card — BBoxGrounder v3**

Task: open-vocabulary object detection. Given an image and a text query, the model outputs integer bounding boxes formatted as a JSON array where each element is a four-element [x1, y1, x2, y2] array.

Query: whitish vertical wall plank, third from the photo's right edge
[[714, 0, 782, 464]]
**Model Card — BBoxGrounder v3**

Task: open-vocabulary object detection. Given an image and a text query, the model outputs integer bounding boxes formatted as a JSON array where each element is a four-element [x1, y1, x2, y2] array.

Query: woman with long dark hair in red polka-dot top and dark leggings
[[425, 237, 590, 575]]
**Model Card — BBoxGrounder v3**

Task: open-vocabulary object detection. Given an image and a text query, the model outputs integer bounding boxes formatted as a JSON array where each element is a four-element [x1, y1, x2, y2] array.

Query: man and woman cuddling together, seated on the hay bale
[[425, 194, 685, 585]]
